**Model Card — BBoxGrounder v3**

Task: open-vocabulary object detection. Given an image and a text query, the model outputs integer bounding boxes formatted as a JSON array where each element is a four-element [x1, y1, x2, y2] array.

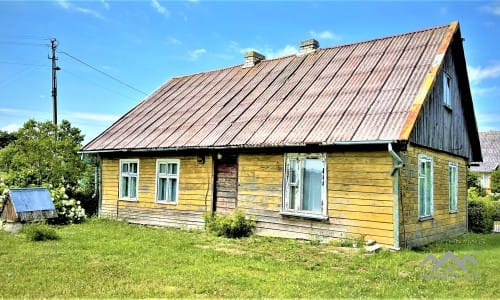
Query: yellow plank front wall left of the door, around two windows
[[99, 156, 212, 228]]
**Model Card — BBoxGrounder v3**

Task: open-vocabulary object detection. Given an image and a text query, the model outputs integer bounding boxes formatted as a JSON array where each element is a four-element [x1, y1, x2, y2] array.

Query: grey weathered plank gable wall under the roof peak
[[410, 51, 472, 160]]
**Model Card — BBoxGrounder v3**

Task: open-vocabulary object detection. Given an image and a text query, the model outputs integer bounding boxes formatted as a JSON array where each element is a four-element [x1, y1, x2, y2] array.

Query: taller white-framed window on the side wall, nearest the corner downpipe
[[418, 154, 434, 218]]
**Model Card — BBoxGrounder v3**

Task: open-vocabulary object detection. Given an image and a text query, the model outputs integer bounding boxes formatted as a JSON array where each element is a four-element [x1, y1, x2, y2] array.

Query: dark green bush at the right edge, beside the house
[[468, 198, 495, 233]]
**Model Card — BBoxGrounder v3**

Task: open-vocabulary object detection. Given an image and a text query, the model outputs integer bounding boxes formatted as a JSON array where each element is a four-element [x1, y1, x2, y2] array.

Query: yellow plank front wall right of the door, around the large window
[[238, 151, 393, 246]]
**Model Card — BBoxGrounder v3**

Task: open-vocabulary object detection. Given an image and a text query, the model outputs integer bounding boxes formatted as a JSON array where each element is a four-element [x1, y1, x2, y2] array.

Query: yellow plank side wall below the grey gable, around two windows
[[399, 145, 467, 247]]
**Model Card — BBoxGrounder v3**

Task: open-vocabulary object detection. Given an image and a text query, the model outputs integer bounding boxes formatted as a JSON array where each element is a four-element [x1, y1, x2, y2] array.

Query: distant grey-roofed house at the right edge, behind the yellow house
[[470, 131, 500, 193]]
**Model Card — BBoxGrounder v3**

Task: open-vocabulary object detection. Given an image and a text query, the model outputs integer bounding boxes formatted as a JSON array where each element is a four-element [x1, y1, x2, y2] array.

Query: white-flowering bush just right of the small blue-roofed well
[[50, 187, 86, 225]]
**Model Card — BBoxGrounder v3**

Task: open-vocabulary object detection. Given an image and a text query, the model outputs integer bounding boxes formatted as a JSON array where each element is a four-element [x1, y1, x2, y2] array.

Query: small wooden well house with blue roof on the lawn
[[1, 188, 57, 223]]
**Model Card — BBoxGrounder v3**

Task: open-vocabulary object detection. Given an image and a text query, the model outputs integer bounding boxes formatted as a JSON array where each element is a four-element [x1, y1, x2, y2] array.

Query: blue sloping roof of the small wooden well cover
[[9, 188, 56, 213]]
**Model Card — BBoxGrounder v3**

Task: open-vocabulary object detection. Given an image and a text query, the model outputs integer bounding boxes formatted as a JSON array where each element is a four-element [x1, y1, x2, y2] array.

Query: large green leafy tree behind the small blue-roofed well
[[0, 120, 90, 193]]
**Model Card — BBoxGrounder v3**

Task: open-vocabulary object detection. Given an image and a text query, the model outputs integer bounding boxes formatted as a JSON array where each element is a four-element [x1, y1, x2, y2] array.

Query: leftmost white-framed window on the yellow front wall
[[119, 159, 139, 200]]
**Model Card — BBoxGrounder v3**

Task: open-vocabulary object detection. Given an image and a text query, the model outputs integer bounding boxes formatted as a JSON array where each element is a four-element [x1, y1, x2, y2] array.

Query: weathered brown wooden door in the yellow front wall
[[213, 155, 238, 213]]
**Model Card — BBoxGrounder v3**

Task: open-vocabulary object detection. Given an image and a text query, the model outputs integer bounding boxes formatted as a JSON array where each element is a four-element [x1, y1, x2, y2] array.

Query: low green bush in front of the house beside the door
[[204, 210, 255, 238]]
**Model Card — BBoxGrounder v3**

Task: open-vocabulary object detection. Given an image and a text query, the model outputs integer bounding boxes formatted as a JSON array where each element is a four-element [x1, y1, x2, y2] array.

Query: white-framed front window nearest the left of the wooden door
[[156, 159, 180, 204]]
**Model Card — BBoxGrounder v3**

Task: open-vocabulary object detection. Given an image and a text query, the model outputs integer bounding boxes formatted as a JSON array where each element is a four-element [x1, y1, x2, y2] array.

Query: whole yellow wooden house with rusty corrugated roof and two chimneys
[[83, 22, 481, 248]]
